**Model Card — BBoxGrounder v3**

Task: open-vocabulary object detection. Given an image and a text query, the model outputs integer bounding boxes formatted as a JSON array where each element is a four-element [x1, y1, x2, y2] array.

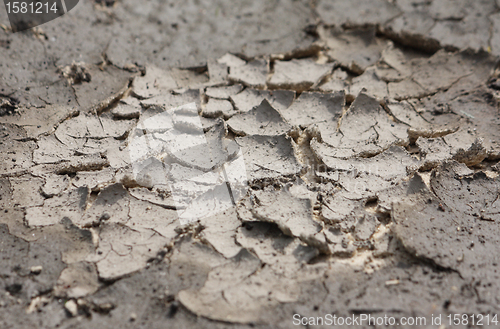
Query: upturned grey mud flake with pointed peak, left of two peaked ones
[[227, 99, 290, 136]]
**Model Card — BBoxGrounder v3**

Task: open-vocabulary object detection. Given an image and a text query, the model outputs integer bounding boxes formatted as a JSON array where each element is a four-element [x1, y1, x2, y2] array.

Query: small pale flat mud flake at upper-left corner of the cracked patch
[[132, 66, 178, 98]]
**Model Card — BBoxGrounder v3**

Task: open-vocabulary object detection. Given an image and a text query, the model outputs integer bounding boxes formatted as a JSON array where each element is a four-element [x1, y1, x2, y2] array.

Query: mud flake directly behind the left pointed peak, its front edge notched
[[230, 88, 295, 112]]
